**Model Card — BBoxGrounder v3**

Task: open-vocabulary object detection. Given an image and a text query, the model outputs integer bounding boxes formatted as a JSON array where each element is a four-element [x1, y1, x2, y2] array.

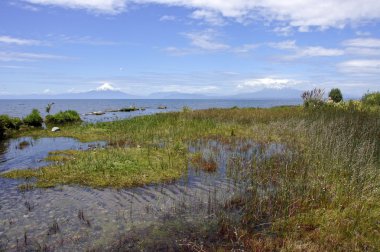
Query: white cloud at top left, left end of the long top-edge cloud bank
[[23, 0, 127, 14]]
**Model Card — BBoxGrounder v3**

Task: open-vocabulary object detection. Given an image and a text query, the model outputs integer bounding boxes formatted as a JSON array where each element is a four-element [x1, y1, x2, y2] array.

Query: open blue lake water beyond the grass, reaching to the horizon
[[0, 99, 301, 122]]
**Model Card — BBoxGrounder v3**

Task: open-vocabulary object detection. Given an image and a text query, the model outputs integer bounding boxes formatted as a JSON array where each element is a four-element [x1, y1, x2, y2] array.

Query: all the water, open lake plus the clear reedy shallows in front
[[0, 100, 300, 251]]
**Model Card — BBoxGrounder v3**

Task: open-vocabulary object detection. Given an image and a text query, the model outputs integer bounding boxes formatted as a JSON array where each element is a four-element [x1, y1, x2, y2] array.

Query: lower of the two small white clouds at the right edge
[[338, 59, 380, 74]]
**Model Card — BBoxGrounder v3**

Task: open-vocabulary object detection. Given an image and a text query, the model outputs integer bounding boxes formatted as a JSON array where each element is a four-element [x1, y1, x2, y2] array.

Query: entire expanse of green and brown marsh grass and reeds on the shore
[[3, 91, 380, 251]]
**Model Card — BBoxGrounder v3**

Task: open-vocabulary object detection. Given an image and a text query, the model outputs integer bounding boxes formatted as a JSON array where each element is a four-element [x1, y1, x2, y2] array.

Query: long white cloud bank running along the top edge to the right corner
[[23, 0, 380, 31]]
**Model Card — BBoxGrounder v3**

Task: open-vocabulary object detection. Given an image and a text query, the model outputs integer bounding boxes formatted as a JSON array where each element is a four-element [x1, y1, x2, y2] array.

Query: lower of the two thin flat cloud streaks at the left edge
[[0, 51, 70, 61]]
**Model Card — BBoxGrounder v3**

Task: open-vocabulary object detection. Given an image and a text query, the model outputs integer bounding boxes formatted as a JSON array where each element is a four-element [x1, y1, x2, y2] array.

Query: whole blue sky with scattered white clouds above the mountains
[[0, 0, 380, 95]]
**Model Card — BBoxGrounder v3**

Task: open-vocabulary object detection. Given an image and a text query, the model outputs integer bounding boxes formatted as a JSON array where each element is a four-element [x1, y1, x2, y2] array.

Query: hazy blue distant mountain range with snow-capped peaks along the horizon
[[0, 88, 308, 100]]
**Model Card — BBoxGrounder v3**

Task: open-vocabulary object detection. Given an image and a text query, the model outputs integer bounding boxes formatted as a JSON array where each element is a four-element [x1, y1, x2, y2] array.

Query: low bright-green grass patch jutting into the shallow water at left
[[4, 148, 186, 188]]
